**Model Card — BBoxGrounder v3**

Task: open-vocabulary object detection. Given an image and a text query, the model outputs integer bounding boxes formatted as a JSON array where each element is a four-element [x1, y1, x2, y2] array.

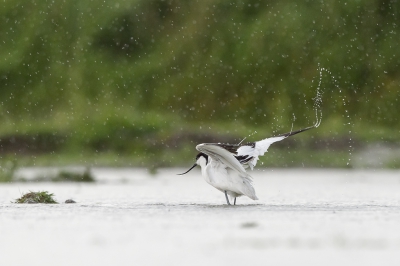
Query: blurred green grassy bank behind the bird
[[0, 0, 400, 169]]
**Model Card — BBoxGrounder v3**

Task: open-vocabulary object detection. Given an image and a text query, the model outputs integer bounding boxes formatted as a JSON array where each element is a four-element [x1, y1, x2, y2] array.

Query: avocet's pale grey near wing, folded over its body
[[196, 143, 248, 176]]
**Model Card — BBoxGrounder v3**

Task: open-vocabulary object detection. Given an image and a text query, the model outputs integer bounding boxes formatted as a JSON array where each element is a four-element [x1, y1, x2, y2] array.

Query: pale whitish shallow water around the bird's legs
[[0, 168, 400, 265]]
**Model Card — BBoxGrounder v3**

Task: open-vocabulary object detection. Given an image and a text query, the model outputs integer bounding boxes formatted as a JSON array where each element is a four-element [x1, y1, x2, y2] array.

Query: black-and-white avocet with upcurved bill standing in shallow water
[[179, 125, 318, 205]]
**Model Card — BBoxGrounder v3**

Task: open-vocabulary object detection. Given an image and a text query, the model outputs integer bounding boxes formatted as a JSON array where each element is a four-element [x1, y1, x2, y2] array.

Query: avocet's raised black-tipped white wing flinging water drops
[[236, 126, 315, 169]]
